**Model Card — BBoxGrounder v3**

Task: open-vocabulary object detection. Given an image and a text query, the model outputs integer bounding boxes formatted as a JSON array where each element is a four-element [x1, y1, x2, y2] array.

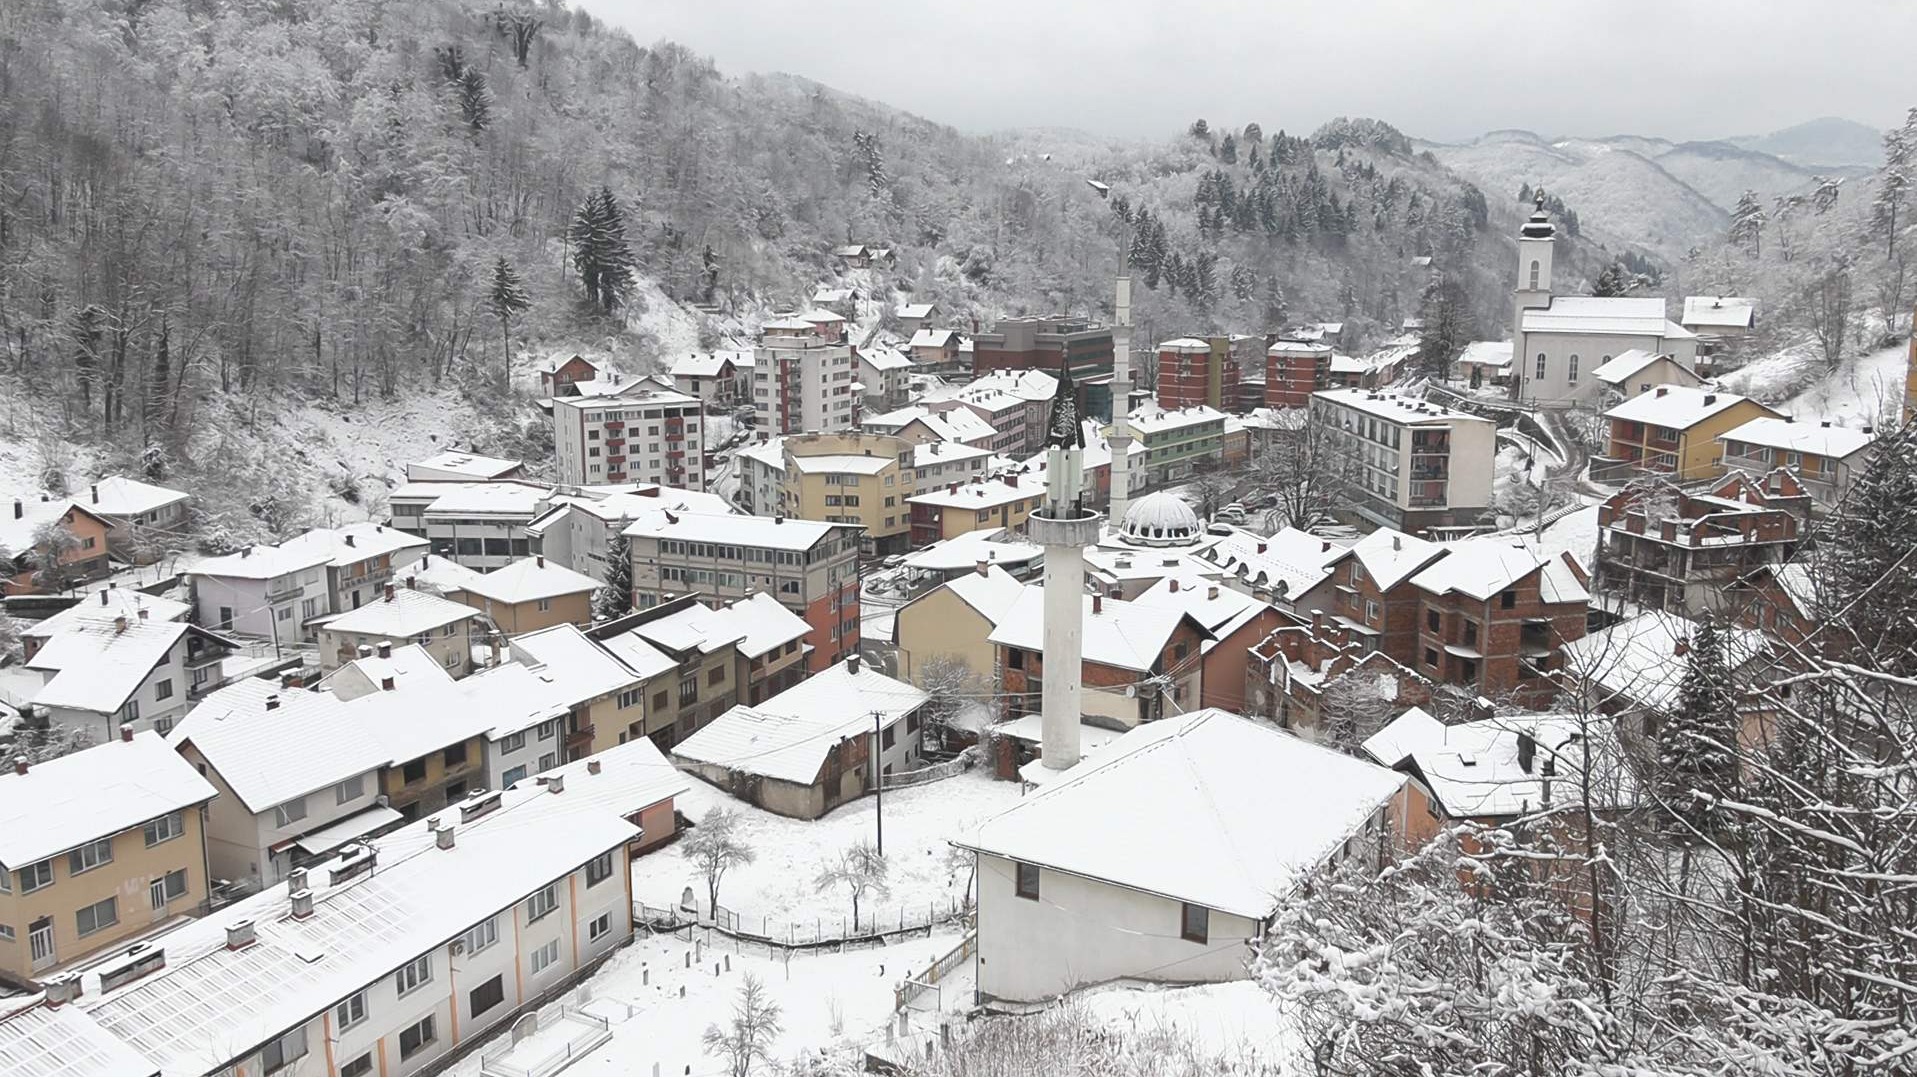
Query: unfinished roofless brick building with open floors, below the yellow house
[[1597, 472, 1804, 616]]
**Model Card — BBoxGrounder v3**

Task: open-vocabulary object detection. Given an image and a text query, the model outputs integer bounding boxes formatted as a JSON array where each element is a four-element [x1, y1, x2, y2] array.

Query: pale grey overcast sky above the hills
[[575, 0, 1917, 140]]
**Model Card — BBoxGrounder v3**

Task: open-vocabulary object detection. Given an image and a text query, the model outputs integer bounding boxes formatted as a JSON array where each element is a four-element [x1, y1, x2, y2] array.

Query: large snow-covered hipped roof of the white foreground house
[[957, 708, 1405, 919]]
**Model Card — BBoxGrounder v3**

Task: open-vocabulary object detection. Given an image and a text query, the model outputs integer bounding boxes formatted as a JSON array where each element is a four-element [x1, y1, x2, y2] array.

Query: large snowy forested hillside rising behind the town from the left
[[0, 0, 1633, 529]]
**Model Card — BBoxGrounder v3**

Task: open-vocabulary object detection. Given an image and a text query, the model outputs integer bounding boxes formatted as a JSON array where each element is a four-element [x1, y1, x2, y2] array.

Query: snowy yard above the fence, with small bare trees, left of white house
[[633, 767, 1020, 934]]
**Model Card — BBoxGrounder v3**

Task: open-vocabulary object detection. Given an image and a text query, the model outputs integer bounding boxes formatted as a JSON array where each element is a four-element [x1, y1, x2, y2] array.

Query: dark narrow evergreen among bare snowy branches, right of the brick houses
[[1656, 618, 1739, 836]]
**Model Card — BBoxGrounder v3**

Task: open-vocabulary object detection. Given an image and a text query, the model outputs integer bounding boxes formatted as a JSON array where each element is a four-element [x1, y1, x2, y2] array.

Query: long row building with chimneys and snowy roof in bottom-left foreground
[[0, 742, 686, 1074]]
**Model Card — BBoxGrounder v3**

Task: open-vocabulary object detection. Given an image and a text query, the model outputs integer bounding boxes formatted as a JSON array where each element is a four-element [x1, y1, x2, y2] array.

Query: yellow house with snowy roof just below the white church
[[1605, 386, 1783, 480]]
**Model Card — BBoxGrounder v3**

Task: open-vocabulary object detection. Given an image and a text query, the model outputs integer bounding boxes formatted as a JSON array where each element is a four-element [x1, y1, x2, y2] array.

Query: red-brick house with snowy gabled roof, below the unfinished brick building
[[1405, 537, 1591, 706]]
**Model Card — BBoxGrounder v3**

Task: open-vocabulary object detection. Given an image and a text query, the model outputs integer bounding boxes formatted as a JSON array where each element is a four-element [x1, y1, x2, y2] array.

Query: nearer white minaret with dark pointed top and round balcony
[[1026, 364, 1102, 775]]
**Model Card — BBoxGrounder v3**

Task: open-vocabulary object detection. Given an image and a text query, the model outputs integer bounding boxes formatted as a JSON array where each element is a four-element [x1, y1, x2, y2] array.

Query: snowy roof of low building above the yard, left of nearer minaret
[[673, 664, 928, 785]]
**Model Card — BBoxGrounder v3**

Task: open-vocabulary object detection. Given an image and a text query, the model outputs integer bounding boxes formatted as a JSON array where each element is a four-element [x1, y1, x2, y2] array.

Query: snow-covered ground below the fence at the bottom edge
[[449, 932, 960, 1076]]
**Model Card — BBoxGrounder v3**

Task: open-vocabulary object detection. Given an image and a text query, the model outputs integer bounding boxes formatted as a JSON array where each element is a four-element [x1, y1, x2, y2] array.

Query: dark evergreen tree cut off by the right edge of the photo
[[1817, 416, 1917, 673]]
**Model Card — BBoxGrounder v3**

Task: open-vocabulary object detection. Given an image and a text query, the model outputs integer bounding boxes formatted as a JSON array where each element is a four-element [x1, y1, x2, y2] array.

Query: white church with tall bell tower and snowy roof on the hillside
[[1511, 198, 1697, 407]]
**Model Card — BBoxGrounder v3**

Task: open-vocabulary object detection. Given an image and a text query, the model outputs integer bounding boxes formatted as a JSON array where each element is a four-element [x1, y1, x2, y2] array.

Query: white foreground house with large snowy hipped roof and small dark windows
[[955, 708, 1405, 1001]]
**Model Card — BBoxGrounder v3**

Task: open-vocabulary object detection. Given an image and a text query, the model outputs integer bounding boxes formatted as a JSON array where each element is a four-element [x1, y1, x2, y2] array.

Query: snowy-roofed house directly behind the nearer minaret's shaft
[[989, 585, 1213, 727]]
